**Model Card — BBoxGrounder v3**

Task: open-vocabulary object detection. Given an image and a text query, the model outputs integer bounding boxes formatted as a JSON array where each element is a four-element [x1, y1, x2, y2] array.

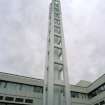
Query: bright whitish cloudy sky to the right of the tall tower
[[62, 0, 105, 84]]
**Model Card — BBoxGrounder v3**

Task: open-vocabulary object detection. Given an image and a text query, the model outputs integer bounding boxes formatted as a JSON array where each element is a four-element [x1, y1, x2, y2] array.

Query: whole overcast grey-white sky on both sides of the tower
[[0, 0, 105, 84]]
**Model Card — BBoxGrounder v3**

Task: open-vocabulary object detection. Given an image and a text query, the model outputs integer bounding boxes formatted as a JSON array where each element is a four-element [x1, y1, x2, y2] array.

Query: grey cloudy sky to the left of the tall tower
[[0, 0, 48, 77]]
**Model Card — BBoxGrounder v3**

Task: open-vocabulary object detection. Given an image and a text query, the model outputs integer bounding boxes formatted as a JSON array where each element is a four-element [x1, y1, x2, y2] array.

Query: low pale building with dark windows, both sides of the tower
[[0, 73, 105, 105]]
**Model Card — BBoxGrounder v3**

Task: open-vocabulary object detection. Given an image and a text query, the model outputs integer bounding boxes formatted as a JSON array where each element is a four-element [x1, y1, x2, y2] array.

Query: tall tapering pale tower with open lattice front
[[43, 0, 71, 105]]
